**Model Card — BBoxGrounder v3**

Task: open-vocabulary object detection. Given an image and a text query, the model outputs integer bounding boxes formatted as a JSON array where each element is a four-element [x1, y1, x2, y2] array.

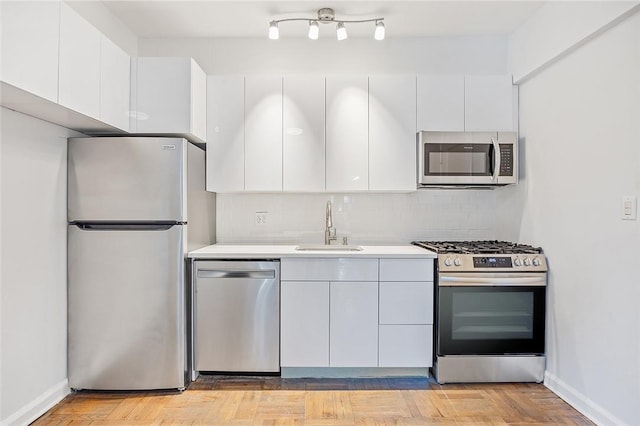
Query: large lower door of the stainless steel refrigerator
[[68, 225, 186, 390]]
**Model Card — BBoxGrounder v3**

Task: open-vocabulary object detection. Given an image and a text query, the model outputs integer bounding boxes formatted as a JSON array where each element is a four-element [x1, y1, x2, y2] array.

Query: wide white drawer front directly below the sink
[[280, 258, 378, 281]]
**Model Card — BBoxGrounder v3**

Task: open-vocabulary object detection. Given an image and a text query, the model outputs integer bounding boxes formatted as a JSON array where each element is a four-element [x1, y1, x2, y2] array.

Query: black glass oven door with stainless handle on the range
[[436, 273, 546, 356]]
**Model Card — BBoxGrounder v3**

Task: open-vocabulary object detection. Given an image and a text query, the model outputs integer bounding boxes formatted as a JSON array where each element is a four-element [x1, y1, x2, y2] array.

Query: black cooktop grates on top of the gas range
[[411, 241, 542, 254]]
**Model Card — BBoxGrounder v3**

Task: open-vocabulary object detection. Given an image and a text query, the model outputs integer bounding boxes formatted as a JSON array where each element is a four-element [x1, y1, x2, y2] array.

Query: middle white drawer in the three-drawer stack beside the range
[[380, 282, 433, 324]]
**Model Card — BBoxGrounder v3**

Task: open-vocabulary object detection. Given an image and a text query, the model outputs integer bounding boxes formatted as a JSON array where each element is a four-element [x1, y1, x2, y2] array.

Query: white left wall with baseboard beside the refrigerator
[[0, 108, 75, 425]]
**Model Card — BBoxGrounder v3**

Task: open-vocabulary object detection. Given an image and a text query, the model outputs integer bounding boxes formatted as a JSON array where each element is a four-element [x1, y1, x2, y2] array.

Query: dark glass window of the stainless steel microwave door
[[424, 143, 493, 176]]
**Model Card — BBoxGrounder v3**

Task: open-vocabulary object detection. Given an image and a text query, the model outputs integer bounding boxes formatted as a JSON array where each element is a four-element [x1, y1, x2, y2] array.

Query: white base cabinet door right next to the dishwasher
[[280, 281, 329, 367]]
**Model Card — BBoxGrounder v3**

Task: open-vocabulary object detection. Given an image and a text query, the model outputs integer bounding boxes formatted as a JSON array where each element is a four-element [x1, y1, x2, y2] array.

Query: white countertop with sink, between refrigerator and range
[[188, 244, 437, 259]]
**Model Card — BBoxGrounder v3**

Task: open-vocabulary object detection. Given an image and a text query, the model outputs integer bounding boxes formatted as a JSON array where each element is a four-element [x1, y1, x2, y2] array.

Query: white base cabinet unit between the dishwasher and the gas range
[[280, 258, 433, 368]]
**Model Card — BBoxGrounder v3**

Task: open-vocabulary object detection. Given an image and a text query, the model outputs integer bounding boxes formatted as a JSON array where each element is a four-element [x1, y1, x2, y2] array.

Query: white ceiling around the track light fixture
[[102, 0, 544, 39]]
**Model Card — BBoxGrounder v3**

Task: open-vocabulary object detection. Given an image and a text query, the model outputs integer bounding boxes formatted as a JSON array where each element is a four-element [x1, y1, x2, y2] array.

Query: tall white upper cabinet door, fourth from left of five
[[326, 76, 369, 191]]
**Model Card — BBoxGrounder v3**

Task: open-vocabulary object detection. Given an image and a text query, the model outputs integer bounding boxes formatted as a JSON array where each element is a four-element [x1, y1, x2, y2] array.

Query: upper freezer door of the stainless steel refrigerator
[[67, 137, 188, 222]]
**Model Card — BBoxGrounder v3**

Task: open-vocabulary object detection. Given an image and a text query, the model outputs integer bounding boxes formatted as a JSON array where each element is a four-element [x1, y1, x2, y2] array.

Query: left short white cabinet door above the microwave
[[416, 75, 464, 131]]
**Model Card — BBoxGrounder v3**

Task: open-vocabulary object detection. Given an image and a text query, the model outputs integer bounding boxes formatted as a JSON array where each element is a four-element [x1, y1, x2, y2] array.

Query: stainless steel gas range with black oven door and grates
[[412, 241, 547, 383]]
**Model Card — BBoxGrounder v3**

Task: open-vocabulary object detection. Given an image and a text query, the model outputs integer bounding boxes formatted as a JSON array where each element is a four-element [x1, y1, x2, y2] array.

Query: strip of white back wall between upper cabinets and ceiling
[[138, 34, 507, 74]]
